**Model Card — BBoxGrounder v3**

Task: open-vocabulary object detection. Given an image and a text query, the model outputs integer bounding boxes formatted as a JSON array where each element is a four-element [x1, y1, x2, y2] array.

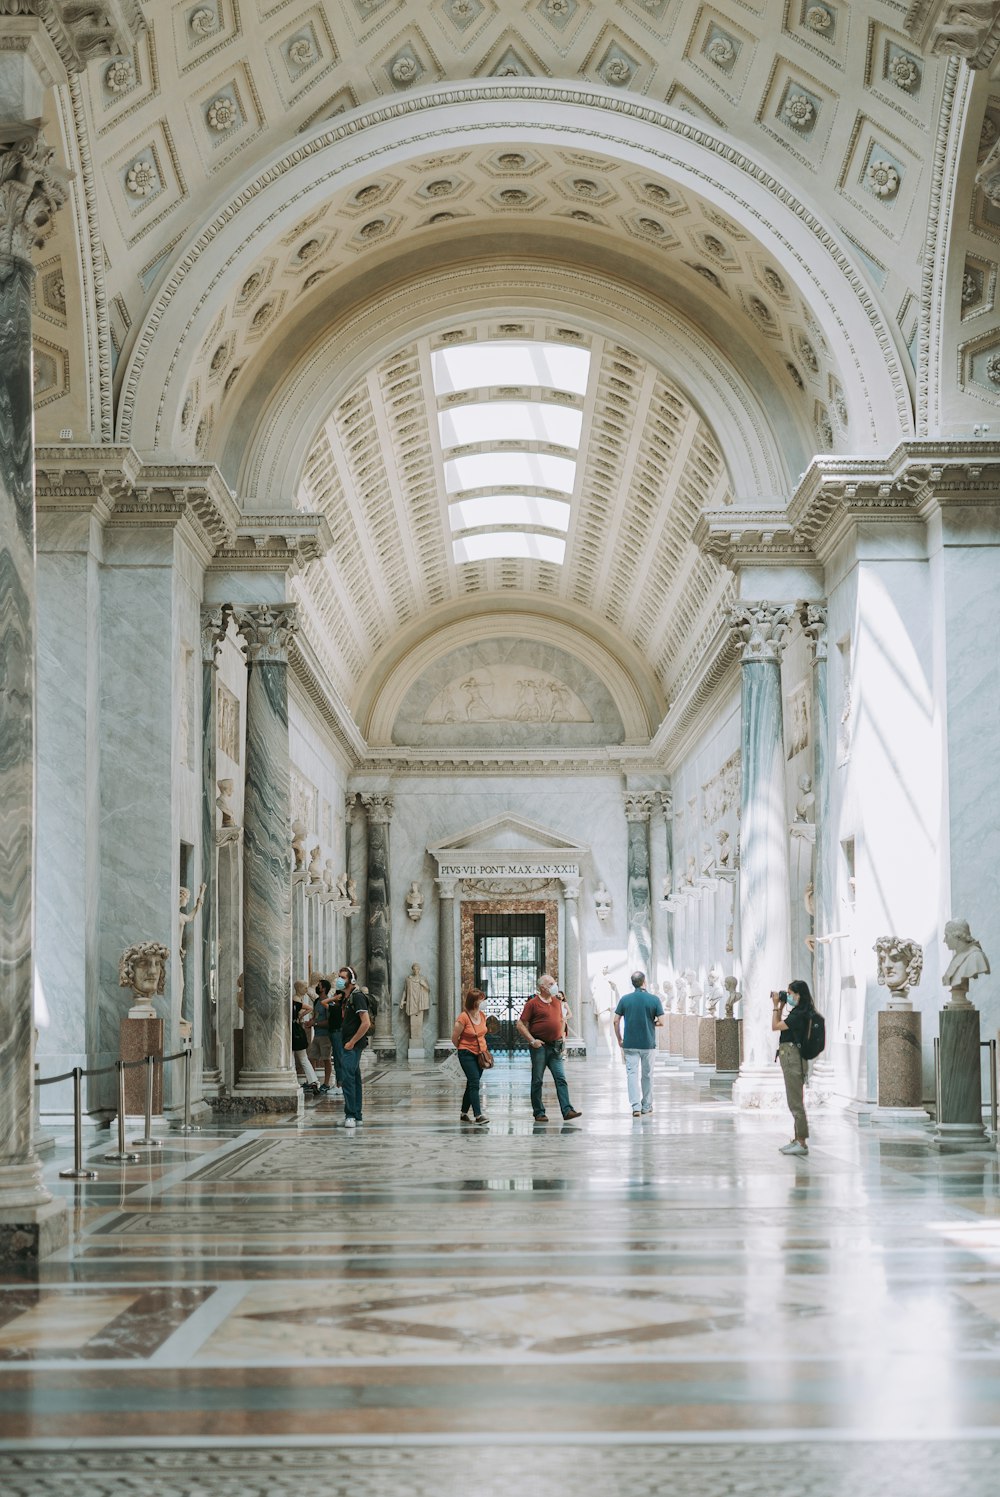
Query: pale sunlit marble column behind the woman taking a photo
[[729, 602, 793, 1111]]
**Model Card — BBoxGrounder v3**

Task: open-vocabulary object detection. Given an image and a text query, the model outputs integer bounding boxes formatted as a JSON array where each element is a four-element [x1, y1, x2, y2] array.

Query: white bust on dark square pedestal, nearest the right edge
[[934, 921, 990, 1148]]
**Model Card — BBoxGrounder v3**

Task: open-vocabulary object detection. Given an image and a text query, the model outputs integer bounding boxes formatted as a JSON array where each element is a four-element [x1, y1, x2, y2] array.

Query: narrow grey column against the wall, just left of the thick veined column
[[195, 606, 229, 1091]]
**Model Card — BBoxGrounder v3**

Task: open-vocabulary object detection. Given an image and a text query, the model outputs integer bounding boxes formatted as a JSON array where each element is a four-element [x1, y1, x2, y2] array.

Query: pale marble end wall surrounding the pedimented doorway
[[389, 774, 629, 1049]]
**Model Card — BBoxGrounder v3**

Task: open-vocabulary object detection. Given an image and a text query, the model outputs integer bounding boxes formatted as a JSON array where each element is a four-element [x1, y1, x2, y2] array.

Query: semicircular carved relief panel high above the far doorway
[[392, 639, 624, 747]]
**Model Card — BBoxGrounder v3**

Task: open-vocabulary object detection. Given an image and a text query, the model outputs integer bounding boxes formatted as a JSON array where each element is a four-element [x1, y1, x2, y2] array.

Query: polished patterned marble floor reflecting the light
[[0, 1061, 1000, 1497]]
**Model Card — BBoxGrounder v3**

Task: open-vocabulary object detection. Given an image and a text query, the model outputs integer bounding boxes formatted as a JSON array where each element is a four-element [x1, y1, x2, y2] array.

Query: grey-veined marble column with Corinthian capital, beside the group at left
[[232, 603, 299, 1112]]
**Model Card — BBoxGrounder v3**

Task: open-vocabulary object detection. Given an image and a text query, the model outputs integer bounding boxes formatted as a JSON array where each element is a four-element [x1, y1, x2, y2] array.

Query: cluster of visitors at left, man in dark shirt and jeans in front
[[292, 967, 371, 1129]]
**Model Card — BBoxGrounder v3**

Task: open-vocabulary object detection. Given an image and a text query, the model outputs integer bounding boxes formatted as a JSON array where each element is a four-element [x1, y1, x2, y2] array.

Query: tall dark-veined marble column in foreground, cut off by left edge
[[0, 125, 67, 1256]]
